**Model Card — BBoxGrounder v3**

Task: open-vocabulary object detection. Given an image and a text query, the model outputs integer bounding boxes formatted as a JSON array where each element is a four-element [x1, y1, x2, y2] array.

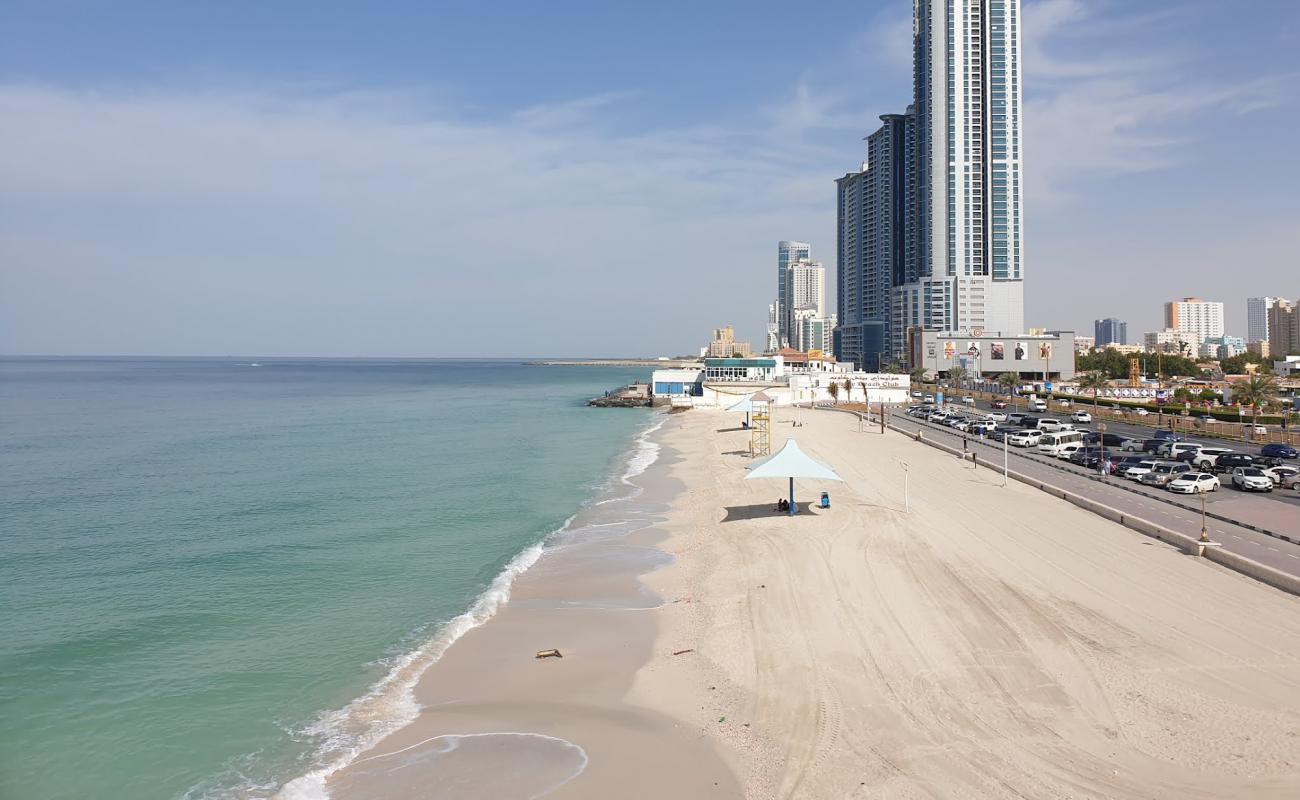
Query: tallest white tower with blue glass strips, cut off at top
[[896, 0, 1024, 334]]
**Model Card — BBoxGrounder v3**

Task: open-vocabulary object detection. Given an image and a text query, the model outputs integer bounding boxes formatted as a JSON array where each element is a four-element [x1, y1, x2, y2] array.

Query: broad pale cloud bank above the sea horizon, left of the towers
[[0, 86, 833, 354]]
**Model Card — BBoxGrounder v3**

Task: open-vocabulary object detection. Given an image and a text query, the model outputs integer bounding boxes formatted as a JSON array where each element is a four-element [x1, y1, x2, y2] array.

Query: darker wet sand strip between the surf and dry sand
[[313, 415, 740, 800]]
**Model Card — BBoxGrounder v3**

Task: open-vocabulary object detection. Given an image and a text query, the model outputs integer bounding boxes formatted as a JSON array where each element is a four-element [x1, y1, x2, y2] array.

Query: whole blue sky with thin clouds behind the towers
[[0, 0, 1300, 356]]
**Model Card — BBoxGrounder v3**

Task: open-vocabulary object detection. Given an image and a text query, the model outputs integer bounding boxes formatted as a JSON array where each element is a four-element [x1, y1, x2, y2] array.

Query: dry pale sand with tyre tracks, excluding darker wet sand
[[637, 411, 1300, 799]]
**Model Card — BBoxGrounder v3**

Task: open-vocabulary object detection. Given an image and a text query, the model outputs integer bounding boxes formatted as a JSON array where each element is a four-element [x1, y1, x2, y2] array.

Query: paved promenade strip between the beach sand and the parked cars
[[889, 412, 1300, 575]]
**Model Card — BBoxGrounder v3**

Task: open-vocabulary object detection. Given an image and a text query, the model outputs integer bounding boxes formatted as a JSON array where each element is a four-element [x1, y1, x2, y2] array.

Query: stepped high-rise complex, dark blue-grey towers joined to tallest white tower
[[836, 0, 1024, 364]]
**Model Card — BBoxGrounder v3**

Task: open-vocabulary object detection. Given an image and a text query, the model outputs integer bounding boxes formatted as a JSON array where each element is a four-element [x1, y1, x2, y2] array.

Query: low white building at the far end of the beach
[[650, 349, 909, 408]]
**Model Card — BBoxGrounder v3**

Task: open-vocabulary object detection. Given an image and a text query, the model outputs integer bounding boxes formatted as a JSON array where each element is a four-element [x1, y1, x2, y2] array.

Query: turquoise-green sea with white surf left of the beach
[[0, 359, 651, 800]]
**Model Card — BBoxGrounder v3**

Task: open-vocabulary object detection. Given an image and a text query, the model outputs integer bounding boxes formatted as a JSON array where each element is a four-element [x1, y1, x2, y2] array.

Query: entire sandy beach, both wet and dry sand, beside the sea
[[319, 410, 1300, 799]]
